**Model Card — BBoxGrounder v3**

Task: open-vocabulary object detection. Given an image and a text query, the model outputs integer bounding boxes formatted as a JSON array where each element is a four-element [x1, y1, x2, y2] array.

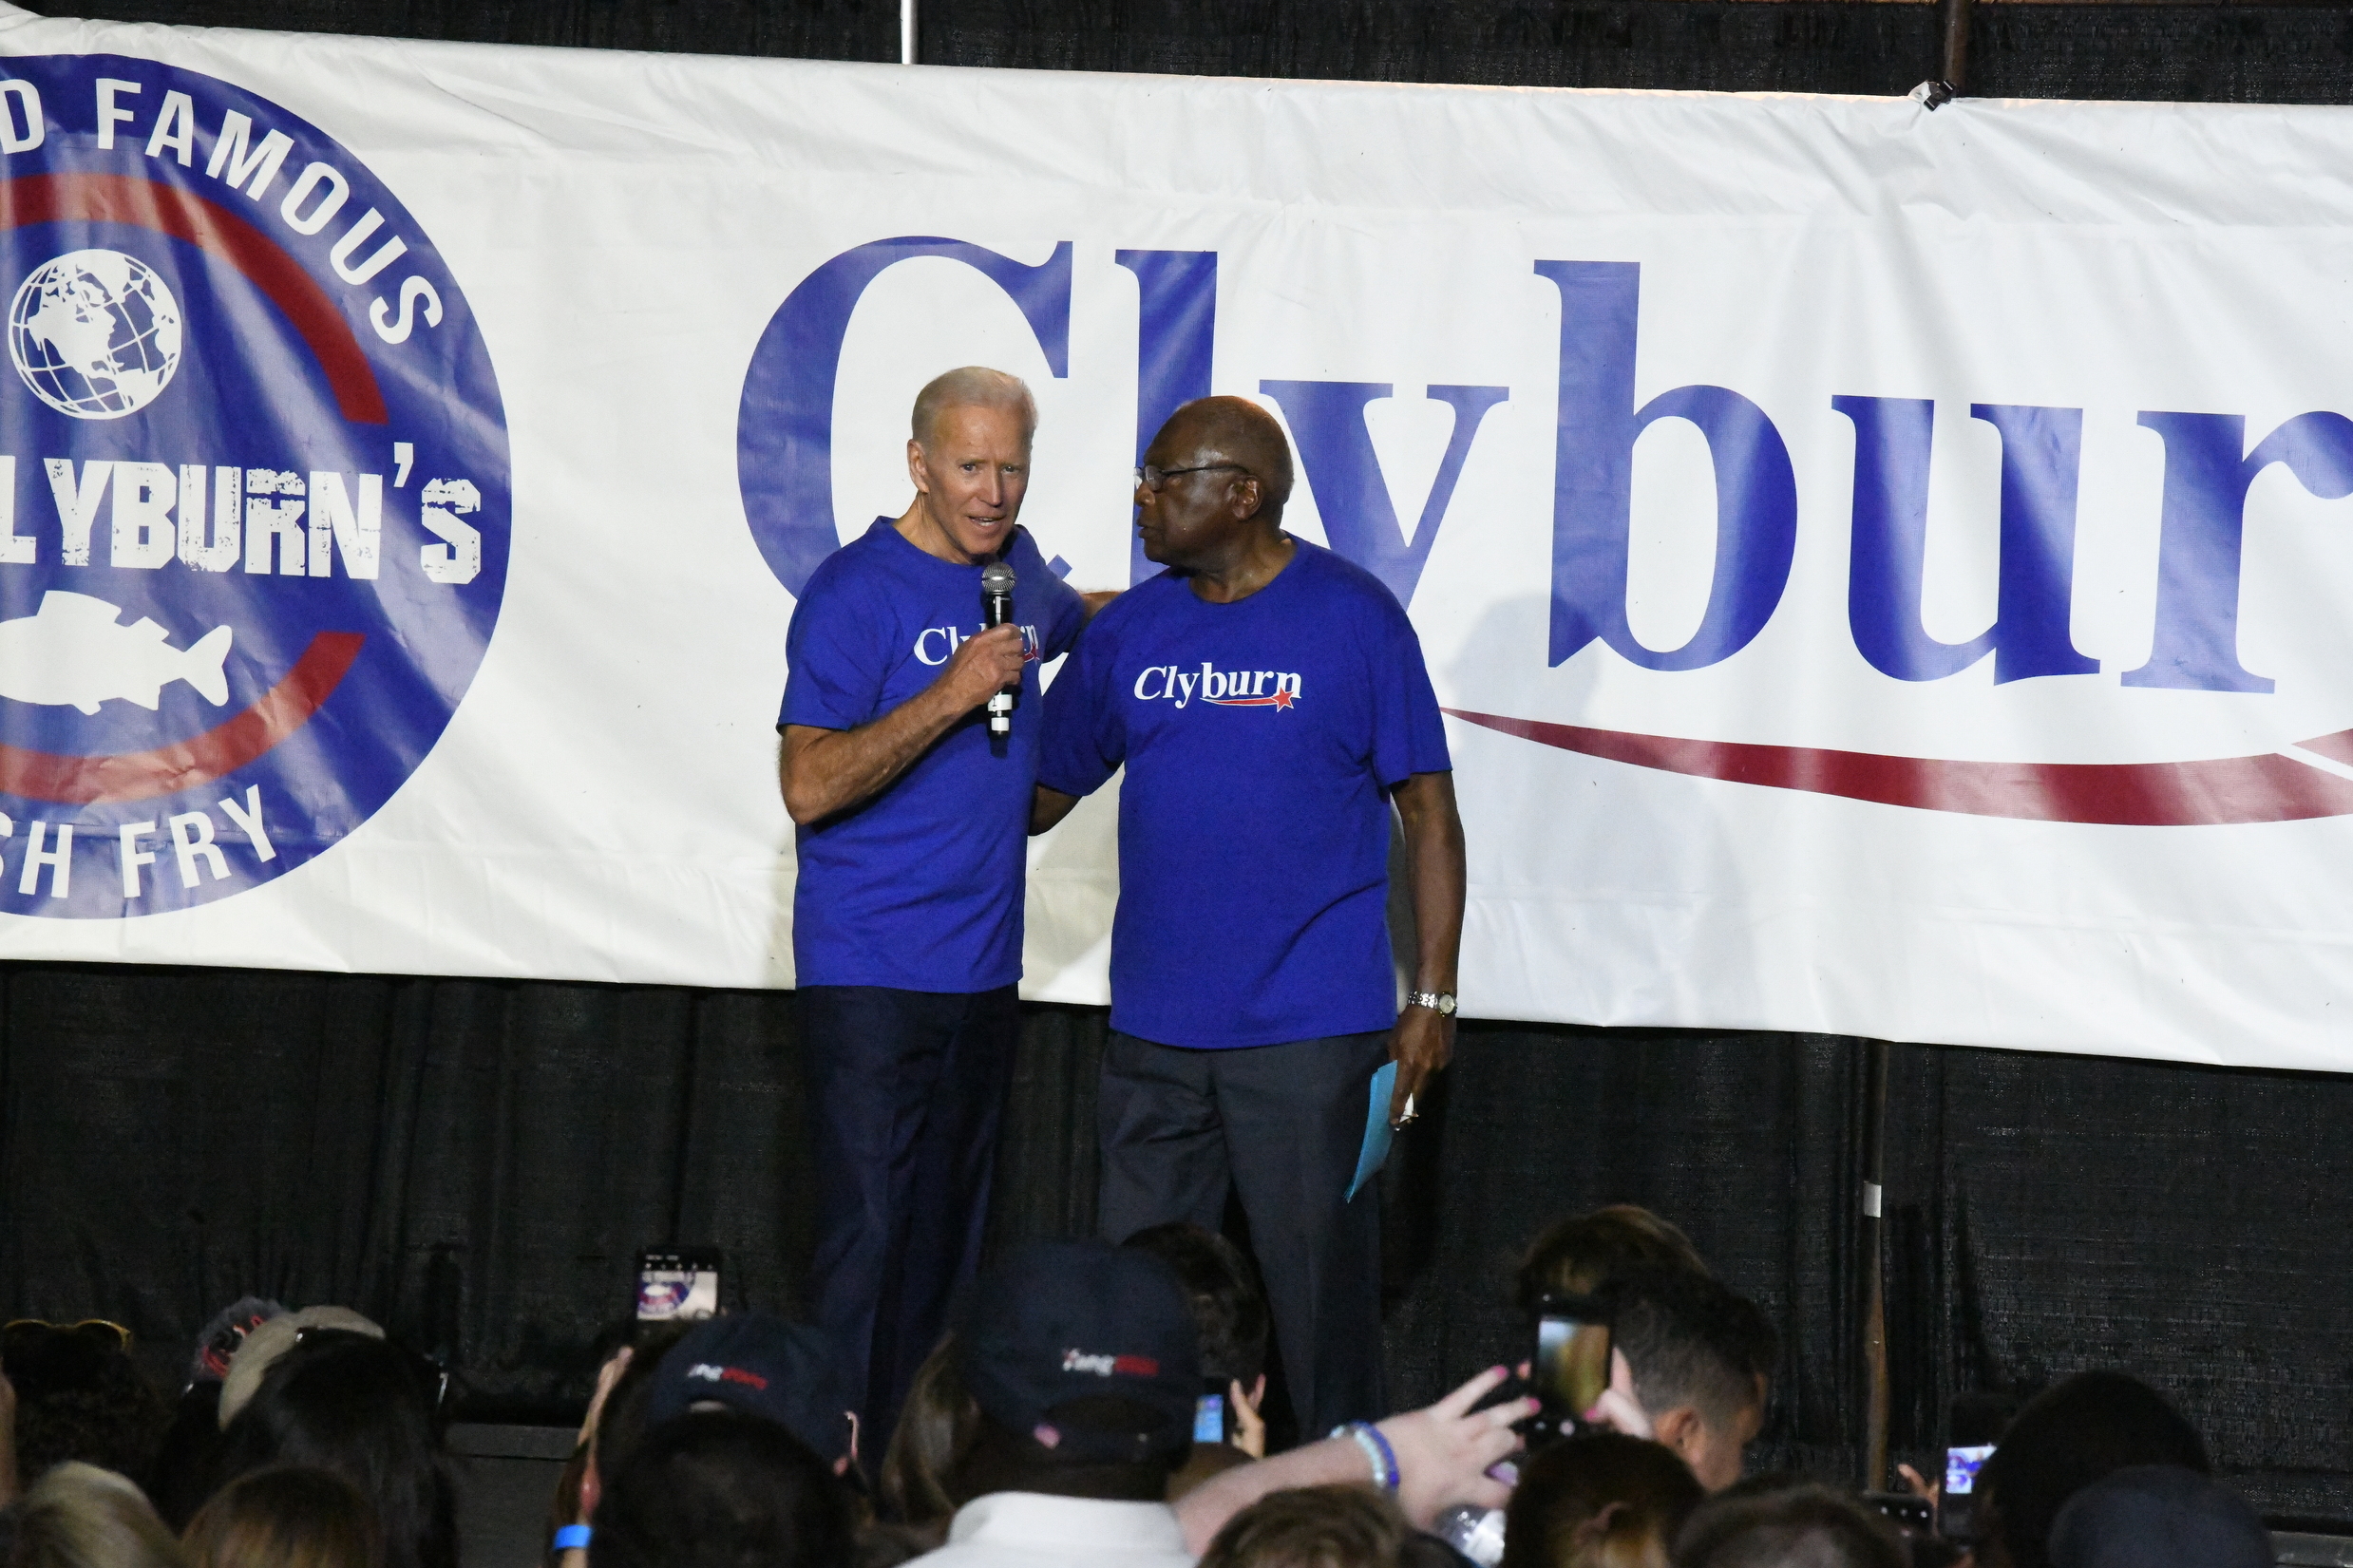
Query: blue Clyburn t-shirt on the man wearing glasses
[[1037, 540, 1452, 1048]]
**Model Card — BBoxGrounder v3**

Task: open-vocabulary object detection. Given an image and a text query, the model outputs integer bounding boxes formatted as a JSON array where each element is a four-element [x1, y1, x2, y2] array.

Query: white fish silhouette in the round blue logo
[[0, 588, 233, 712]]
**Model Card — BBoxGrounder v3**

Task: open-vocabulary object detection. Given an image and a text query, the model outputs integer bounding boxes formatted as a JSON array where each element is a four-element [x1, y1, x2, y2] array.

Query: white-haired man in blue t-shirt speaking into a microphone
[[779, 367, 1087, 1455]]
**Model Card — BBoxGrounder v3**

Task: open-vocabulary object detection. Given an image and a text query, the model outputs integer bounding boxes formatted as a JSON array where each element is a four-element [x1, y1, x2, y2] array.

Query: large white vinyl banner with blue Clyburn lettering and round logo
[[0, 7, 2353, 1069]]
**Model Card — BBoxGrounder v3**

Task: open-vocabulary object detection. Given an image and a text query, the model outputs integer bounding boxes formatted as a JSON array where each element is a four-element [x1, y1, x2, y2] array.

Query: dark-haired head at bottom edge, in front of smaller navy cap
[[588, 1410, 857, 1568]]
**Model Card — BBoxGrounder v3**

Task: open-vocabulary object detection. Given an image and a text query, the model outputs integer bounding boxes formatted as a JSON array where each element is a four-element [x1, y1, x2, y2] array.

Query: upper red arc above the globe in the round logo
[[0, 174, 390, 425]]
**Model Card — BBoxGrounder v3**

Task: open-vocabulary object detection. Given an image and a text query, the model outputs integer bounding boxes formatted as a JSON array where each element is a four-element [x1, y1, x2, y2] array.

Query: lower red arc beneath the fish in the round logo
[[0, 633, 367, 806]]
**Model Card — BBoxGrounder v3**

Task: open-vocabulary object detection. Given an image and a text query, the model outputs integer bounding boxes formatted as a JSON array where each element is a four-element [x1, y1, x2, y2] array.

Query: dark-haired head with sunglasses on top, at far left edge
[[0, 1321, 172, 1483]]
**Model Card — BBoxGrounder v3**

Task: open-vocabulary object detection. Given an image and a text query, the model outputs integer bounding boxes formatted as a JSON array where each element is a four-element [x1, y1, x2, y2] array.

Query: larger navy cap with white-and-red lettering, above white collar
[[958, 1241, 1200, 1463]]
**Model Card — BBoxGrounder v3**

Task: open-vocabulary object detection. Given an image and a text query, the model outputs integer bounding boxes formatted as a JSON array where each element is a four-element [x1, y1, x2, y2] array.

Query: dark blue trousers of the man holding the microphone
[[800, 985, 1021, 1464]]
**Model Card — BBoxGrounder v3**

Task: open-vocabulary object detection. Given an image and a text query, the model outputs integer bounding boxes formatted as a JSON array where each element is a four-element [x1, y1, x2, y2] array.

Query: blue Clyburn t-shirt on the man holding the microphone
[[776, 518, 1085, 992]]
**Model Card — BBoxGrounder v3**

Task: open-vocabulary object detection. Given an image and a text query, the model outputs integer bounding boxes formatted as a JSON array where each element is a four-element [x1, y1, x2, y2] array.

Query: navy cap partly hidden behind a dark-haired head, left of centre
[[645, 1312, 849, 1464]]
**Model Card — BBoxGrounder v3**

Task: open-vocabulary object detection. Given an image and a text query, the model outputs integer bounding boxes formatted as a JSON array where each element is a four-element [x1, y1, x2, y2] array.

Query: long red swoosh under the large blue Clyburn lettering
[[1447, 708, 2353, 827]]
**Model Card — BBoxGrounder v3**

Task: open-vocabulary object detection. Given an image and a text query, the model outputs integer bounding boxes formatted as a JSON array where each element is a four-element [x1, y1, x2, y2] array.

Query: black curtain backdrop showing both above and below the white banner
[[13, 0, 2353, 1519]]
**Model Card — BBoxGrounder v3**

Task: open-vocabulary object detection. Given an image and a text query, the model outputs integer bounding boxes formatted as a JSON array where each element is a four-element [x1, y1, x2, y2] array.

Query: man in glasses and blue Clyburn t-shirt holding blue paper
[[1031, 397, 1464, 1431]]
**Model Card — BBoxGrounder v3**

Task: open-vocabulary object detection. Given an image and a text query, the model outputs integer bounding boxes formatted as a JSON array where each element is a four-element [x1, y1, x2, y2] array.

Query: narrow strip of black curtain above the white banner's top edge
[[28, 0, 2353, 104]]
